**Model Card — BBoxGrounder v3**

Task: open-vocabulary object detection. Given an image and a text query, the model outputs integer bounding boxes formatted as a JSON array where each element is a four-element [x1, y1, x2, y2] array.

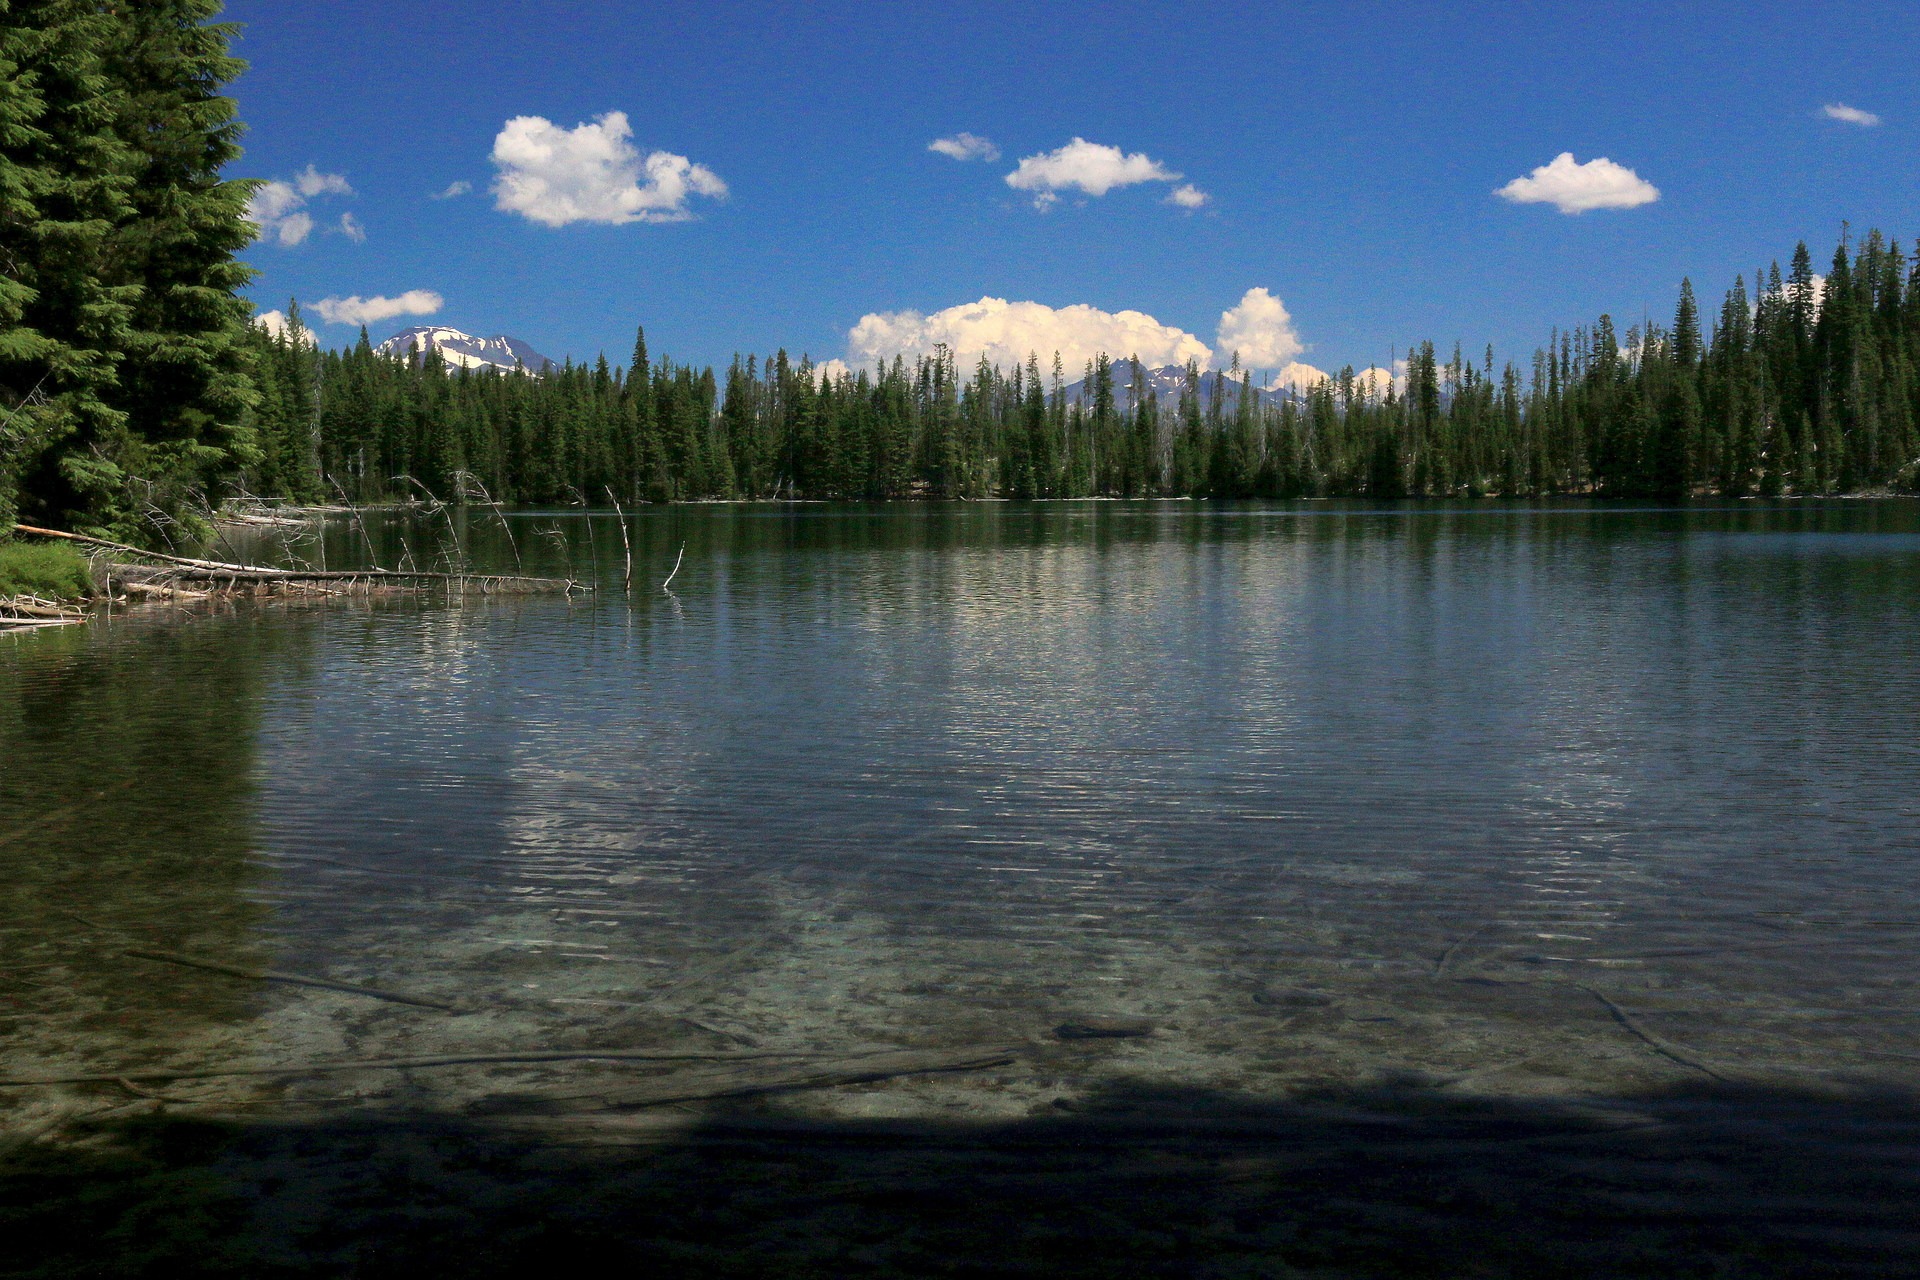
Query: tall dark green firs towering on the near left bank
[[0, 0, 255, 541]]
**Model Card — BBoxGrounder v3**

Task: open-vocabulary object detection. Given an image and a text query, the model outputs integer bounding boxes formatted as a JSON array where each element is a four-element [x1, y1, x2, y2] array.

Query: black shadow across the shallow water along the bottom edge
[[0, 1086, 1920, 1278]]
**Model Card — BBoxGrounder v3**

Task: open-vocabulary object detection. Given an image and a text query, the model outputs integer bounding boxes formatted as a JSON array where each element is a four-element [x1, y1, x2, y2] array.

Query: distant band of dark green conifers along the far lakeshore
[[248, 232, 1920, 503]]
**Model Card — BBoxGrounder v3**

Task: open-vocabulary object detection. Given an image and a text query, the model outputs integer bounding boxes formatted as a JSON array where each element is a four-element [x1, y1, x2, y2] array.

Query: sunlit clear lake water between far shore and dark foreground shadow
[[0, 501, 1920, 1119]]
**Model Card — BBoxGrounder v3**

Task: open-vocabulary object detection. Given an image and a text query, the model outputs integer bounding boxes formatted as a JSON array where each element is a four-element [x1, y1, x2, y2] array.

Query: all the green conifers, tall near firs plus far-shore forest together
[[0, 0, 1920, 543]]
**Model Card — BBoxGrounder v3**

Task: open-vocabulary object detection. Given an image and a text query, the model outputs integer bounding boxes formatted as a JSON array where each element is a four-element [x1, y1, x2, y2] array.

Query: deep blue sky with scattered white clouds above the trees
[[228, 0, 1920, 379]]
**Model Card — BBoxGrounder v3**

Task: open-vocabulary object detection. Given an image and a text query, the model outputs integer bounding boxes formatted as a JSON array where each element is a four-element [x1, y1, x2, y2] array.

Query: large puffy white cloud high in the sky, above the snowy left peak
[[493, 111, 726, 226]]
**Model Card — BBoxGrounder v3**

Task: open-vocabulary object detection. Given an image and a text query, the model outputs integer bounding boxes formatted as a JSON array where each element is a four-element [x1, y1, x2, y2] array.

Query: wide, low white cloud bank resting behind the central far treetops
[[847, 297, 1213, 376]]
